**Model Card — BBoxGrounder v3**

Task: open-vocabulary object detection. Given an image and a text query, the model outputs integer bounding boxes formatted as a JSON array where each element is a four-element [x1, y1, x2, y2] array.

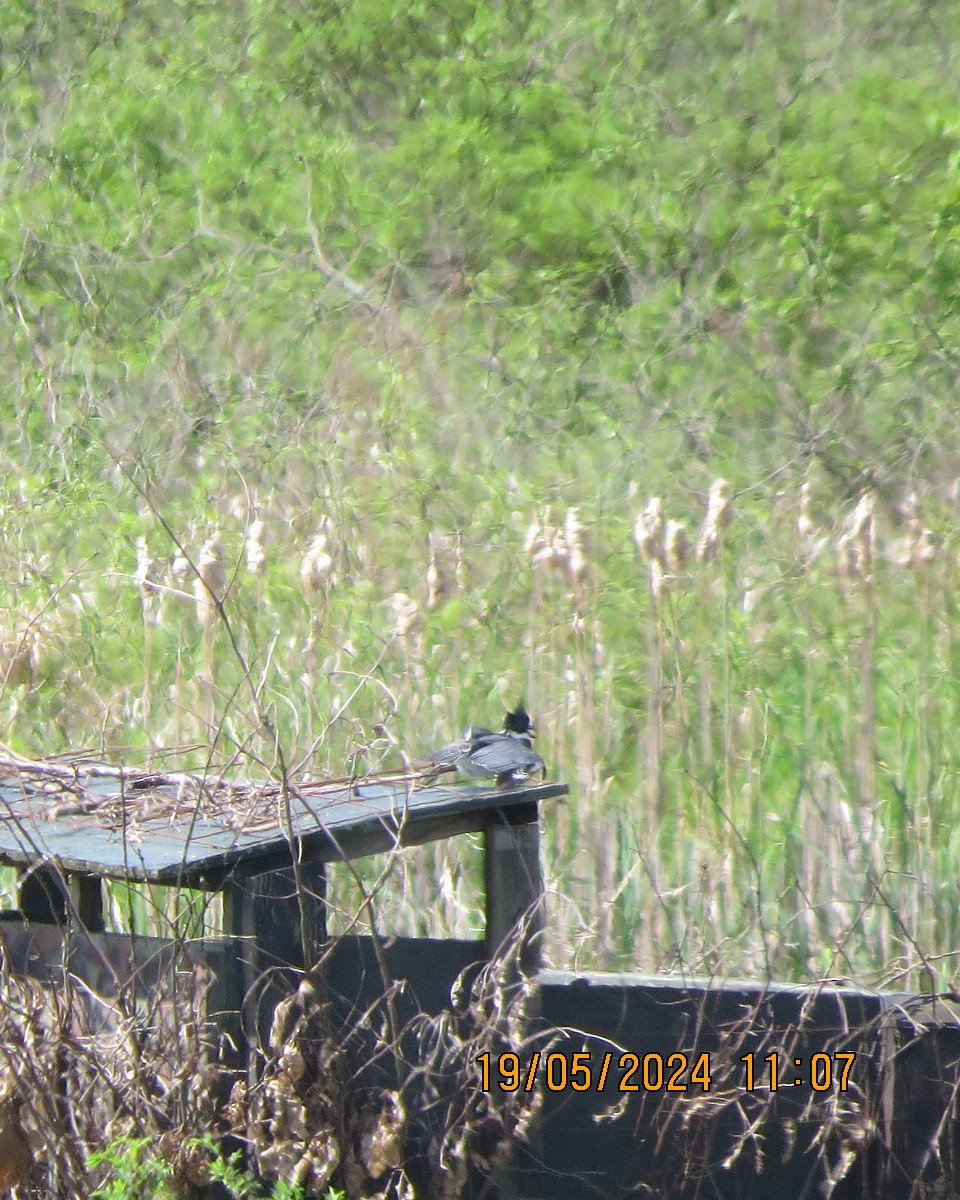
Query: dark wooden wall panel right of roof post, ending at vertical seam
[[528, 971, 888, 1200]]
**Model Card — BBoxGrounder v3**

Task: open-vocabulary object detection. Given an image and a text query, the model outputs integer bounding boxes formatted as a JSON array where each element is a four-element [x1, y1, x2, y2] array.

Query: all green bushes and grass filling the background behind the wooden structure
[[0, 0, 960, 993]]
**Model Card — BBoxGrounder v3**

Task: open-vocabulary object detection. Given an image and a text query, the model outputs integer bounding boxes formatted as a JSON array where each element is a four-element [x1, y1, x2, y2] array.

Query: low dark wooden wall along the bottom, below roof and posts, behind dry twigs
[[0, 918, 960, 1200]]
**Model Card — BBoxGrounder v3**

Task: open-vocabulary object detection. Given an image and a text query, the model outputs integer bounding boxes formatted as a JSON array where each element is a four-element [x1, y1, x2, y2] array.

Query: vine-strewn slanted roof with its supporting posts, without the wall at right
[[0, 763, 566, 1099]]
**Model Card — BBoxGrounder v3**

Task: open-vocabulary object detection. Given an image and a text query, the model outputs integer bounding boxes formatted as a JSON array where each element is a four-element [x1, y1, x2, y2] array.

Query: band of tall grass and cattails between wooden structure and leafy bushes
[[2, 429, 960, 986]]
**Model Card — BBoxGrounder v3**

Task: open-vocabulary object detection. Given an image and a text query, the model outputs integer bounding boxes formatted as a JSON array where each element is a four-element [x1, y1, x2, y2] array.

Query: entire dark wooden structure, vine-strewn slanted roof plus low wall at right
[[0, 763, 960, 1200]]
